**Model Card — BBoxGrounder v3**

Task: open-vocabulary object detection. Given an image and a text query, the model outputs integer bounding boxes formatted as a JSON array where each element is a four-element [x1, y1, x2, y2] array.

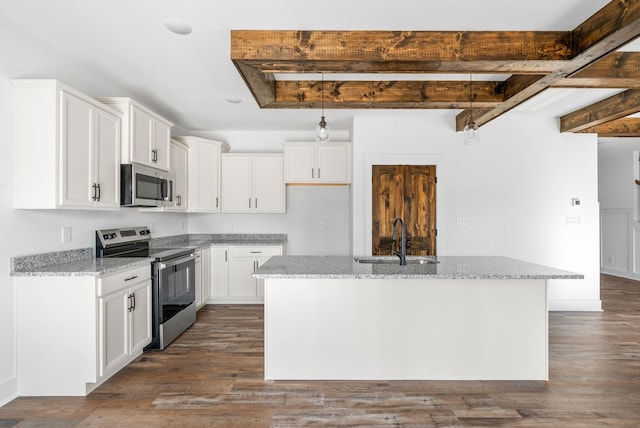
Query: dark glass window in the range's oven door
[[158, 260, 196, 323]]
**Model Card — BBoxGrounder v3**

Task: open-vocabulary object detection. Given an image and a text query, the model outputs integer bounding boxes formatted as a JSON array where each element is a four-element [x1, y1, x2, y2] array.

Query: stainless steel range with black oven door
[[96, 227, 196, 350]]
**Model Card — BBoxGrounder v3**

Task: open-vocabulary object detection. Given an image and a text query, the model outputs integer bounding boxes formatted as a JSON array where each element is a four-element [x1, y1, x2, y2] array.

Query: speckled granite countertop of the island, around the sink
[[253, 256, 584, 279]]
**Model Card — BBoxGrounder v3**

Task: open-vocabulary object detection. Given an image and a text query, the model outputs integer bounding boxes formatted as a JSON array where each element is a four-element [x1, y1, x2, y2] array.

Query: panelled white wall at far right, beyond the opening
[[598, 138, 640, 279]]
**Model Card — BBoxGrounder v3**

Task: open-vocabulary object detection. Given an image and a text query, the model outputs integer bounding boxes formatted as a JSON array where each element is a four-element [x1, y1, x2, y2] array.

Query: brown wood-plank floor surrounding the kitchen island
[[0, 275, 640, 428]]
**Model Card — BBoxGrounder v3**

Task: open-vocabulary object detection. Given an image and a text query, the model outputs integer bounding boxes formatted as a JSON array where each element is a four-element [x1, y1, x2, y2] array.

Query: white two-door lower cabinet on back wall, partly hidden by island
[[209, 245, 283, 304]]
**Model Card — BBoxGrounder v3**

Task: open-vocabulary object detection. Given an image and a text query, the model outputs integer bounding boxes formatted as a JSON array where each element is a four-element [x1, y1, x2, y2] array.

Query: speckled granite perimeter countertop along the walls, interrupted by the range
[[9, 234, 287, 276]]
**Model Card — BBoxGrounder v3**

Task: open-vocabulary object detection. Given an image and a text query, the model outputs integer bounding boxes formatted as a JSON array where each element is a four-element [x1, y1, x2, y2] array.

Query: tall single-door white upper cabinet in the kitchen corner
[[174, 136, 229, 213]]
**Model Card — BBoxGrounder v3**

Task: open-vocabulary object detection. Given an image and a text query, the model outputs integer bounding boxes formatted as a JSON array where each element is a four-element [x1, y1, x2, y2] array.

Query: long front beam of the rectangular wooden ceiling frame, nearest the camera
[[231, 30, 572, 63]]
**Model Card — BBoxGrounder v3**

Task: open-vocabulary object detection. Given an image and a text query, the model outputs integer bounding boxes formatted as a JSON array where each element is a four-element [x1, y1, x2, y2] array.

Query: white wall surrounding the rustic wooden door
[[353, 112, 601, 310]]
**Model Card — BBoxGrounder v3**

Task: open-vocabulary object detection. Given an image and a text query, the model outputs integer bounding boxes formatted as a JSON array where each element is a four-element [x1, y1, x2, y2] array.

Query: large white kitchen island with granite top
[[254, 256, 583, 380]]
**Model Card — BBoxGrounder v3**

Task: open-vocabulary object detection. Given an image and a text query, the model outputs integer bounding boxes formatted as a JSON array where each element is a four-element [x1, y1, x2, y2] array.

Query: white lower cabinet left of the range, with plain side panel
[[15, 264, 151, 396]]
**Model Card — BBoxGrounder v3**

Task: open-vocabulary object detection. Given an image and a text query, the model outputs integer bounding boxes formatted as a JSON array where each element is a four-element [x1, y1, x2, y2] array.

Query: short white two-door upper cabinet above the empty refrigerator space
[[283, 142, 352, 184]]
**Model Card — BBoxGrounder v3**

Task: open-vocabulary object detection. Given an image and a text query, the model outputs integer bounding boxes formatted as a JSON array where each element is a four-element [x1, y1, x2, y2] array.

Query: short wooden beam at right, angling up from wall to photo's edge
[[560, 89, 640, 132]]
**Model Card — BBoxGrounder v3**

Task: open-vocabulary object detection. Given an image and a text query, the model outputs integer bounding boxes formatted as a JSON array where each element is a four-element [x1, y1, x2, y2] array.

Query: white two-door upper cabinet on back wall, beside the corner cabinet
[[222, 153, 285, 213]]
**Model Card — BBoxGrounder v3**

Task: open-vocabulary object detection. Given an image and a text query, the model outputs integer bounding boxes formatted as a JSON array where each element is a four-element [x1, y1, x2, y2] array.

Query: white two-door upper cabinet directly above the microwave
[[96, 97, 173, 171]]
